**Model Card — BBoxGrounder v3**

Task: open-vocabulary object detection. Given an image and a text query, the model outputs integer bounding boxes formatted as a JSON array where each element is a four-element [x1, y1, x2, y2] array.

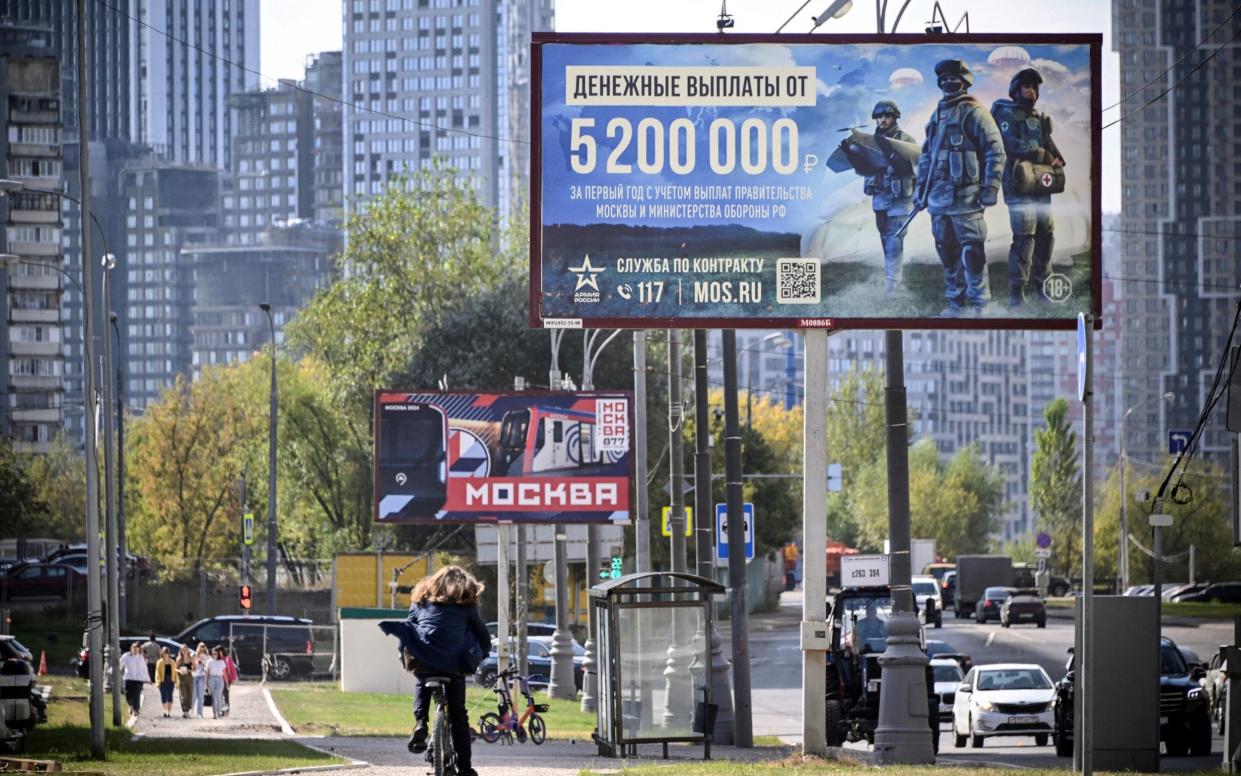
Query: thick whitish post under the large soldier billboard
[[802, 329, 828, 756]]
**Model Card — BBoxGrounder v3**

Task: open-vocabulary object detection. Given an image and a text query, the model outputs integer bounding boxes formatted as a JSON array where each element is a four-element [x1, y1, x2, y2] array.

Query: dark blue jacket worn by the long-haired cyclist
[[380, 603, 491, 673]]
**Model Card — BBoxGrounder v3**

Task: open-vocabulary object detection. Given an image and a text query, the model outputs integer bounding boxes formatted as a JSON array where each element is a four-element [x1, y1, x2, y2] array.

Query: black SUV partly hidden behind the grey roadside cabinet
[[1052, 638, 1211, 757]]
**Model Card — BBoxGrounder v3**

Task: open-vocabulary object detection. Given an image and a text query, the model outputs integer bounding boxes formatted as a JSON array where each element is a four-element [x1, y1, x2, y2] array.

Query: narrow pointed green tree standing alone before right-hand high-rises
[[1030, 399, 1082, 577]]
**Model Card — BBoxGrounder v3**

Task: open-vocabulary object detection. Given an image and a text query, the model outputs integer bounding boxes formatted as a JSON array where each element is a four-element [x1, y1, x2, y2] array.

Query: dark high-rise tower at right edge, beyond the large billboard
[[1104, 0, 1241, 457]]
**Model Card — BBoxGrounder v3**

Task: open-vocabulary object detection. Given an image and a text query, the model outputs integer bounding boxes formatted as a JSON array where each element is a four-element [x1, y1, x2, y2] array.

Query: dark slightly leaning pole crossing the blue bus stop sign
[[724, 329, 755, 749]]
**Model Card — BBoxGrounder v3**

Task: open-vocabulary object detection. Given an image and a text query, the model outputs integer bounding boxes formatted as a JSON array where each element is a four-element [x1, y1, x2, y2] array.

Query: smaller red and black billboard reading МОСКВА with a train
[[375, 391, 633, 524]]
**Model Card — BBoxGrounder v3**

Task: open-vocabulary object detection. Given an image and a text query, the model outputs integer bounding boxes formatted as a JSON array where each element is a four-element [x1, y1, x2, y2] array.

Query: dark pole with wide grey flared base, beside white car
[[875, 330, 938, 765]]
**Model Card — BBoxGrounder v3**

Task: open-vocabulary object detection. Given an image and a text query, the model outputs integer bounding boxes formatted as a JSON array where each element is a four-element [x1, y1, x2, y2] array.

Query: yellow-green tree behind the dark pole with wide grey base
[[850, 438, 1004, 557]]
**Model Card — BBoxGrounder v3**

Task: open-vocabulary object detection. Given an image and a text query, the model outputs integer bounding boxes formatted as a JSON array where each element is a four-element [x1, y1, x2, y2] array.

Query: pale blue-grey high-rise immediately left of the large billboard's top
[[344, 0, 551, 207]]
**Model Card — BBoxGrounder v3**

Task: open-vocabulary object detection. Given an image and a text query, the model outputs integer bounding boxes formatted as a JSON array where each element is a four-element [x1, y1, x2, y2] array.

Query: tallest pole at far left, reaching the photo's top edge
[[77, 0, 105, 760]]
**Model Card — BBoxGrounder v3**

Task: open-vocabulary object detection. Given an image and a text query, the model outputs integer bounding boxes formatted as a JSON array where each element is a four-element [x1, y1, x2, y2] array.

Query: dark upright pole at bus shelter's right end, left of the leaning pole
[[694, 329, 733, 744]]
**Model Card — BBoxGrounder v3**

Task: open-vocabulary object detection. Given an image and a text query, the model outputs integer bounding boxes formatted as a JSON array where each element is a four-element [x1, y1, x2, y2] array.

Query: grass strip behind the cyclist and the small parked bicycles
[[269, 683, 594, 739]]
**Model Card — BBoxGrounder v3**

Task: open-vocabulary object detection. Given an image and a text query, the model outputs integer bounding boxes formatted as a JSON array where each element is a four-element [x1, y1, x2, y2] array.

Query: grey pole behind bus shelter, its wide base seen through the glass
[[664, 329, 694, 726]]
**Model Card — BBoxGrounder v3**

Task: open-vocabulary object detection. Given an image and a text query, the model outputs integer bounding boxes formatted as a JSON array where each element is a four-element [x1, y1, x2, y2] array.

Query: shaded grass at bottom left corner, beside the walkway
[[20, 677, 341, 776]]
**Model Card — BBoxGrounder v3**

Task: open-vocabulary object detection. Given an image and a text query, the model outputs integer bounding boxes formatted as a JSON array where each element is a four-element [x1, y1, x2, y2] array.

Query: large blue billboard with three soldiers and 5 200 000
[[530, 34, 1102, 329]]
